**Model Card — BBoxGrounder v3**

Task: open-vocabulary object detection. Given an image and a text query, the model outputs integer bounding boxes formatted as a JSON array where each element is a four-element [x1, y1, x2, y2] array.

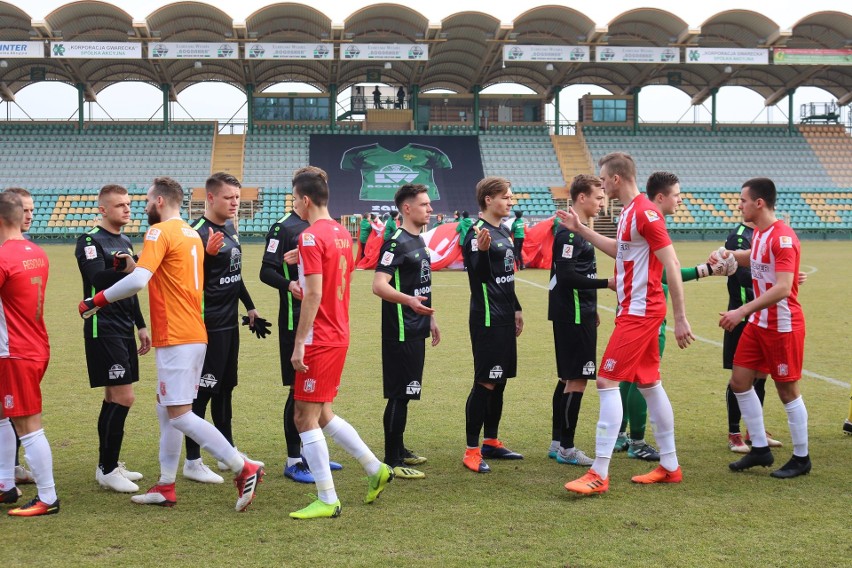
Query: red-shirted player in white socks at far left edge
[[0, 193, 59, 517]]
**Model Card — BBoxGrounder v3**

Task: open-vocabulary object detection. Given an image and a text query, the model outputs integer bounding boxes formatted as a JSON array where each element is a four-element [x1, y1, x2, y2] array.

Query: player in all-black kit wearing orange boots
[[462, 177, 524, 473]]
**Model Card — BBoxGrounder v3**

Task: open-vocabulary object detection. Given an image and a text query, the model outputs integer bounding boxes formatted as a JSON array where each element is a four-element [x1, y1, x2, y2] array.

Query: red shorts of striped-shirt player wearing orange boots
[[598, 315, 664, 385]]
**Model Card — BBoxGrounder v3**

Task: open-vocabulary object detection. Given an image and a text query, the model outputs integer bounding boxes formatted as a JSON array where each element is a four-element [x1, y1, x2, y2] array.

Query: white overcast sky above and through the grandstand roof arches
[[8, 0, 850, 122]]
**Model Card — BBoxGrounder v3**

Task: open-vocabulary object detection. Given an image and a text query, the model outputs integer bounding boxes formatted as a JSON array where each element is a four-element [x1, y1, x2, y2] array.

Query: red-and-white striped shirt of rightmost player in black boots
[[748, 221, 805, 332]]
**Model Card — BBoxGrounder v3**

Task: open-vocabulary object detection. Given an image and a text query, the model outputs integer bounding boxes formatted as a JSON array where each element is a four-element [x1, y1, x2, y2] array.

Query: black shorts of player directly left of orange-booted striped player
[[553, 319, 598, 381]]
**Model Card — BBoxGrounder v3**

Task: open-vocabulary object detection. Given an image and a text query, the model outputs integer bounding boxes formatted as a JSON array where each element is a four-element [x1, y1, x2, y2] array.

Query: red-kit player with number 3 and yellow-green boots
[[290, 170, 393, 519]]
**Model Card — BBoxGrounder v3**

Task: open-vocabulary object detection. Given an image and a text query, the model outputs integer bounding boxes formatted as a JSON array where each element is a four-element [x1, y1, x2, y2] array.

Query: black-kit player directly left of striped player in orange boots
[[547, 174, 607, 466]]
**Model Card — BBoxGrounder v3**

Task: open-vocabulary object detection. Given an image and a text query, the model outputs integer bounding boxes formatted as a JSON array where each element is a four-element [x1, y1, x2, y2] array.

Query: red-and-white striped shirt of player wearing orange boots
[[615, 194, 672, 317]]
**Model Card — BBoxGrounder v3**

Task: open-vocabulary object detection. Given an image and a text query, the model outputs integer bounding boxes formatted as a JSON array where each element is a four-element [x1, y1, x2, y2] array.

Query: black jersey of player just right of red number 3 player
[[376, 229, 432, 341]]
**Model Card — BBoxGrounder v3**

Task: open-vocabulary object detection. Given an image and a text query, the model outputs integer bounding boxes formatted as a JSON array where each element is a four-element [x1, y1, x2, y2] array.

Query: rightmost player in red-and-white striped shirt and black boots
[[714, 178, 811, 478]]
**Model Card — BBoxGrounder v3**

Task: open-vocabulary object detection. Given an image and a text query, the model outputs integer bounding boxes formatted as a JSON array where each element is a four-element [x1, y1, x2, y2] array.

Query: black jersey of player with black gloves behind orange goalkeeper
[[191, 217, 254, 331]]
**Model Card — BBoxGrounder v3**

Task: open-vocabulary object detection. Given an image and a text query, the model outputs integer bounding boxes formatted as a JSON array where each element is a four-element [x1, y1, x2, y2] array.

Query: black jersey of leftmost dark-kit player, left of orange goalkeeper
[[74, 226, 145, 339]]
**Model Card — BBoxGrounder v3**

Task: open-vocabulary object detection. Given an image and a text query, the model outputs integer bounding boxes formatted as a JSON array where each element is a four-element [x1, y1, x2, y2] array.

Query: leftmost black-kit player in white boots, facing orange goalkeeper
[[75, 185, 151, 493]]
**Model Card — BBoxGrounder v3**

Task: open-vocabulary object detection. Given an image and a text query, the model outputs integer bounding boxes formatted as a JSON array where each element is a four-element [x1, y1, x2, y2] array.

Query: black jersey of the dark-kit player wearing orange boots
[[462, 219, 521, 327]]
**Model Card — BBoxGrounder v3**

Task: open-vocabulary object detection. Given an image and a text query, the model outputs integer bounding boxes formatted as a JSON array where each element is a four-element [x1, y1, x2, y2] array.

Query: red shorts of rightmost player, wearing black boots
[[734, 323, 805, 383]]
